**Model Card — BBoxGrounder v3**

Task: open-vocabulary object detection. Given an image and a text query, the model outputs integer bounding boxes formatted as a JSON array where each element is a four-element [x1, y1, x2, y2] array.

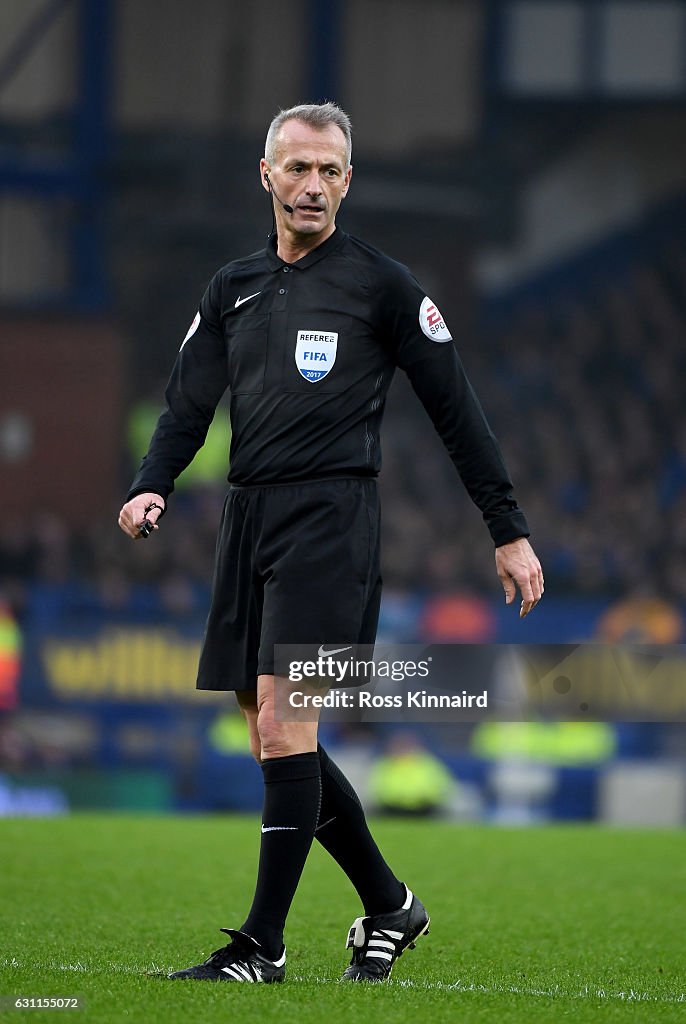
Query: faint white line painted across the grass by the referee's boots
[[2, 956, 686, 1002]]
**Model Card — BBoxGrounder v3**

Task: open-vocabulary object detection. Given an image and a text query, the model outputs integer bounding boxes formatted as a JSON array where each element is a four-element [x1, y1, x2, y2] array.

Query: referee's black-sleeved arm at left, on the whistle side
[[117, 274, 228, 532]]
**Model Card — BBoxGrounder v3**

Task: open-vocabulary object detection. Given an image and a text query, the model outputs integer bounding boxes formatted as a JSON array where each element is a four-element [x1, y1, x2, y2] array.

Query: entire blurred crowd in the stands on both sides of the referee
[[0, 242, 686, 615]]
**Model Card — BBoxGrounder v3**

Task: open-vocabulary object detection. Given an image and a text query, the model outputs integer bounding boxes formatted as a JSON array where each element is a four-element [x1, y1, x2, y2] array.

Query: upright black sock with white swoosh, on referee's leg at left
[[241, 752, 323, 959]]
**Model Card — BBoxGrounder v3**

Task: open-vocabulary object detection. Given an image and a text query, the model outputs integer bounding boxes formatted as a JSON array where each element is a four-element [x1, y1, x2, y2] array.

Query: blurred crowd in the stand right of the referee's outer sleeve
[[480, 251, 686, 600]]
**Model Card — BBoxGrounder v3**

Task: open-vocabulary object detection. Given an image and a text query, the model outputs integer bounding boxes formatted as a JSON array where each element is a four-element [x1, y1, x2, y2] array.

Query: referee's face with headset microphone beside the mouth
[[260, 120, 352, 241]]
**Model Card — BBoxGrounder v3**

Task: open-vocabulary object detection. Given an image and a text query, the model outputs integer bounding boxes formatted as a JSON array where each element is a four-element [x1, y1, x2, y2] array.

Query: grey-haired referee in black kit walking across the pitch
[[119, 103, 543, 982]]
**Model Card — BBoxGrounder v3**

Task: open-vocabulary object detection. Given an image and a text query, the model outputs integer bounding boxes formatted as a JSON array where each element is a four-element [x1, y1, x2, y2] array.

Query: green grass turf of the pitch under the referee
[[0, 815, 686, 1024]]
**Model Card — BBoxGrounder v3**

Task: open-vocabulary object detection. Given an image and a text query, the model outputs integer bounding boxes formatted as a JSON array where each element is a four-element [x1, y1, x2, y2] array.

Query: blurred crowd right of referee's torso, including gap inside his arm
[[370, 243, 686, 601]]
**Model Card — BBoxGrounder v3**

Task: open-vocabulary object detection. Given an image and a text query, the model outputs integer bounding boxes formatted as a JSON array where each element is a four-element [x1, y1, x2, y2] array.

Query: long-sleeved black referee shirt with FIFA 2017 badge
[[128, 228, 528, 545]]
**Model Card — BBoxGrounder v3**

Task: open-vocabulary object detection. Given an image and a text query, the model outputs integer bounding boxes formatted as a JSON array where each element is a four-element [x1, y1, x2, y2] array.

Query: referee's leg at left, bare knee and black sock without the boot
[[239, 676, 321, 959]]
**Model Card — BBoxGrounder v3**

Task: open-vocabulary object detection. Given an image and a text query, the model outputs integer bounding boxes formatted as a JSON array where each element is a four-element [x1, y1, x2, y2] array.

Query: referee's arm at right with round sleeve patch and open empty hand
[[389, 274, 543, 617]]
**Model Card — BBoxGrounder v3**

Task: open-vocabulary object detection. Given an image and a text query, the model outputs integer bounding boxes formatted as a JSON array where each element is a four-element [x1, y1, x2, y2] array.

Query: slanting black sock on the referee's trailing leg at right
[[319, 745, 405, 914]]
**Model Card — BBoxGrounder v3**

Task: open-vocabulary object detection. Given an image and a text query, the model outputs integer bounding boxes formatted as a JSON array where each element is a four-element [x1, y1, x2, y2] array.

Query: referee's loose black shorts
[[198, 477, 381, 690]]
